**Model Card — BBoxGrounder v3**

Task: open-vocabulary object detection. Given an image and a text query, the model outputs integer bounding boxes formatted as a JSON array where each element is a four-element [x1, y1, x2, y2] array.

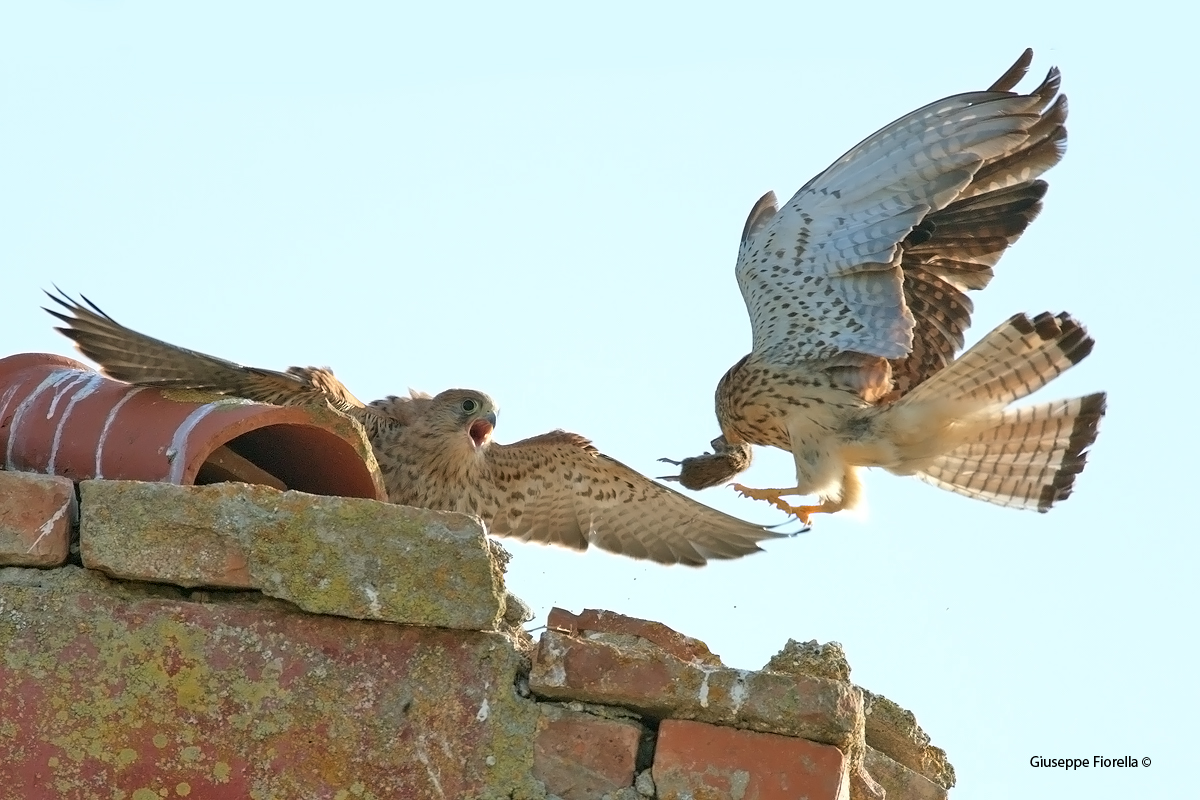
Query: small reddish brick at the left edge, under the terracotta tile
[[0, 470, 78, 566]]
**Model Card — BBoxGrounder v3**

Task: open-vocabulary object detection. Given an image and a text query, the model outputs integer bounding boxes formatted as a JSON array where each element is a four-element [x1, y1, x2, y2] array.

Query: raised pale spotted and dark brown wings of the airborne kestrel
[[737, 52, 1067, 381]]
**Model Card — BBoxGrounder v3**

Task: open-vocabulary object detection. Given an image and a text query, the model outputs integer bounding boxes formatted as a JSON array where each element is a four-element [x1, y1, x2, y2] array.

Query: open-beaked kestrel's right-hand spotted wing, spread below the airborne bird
[[487, 431, 780, 566]]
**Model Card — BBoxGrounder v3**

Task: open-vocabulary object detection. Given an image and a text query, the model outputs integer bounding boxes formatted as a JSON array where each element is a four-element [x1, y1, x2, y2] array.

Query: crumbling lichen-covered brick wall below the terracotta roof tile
[[0, 471, 954, 800]]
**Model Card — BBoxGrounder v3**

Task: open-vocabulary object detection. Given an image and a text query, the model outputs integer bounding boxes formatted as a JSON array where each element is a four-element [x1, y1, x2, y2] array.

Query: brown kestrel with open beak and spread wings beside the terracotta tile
[[47, 295, 781, 566]]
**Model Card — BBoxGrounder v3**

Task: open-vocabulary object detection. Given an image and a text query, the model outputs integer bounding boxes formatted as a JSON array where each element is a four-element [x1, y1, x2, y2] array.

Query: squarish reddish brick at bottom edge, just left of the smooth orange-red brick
[[533, 703, 646, 800]]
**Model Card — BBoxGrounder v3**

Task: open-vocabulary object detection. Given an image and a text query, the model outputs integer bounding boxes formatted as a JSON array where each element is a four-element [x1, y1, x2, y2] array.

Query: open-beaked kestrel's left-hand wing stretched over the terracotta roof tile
[[44, 293, 366, 416]]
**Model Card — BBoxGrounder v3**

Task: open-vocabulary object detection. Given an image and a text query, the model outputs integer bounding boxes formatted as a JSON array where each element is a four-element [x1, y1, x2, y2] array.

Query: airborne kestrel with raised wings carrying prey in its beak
[[664, 50, 1104, 523]]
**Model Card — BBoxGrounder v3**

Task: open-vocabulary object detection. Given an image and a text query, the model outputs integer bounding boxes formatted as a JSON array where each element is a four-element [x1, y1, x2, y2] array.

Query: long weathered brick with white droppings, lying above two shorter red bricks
[[529, 630, 863, 747]]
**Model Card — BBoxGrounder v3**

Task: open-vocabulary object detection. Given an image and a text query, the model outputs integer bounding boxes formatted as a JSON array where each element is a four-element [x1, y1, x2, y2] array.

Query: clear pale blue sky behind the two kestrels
[[0, 1, 1200, 800]]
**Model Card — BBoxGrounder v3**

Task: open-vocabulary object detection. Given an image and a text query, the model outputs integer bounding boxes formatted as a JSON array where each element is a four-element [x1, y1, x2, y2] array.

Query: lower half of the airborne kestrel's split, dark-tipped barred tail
[[916, 392, 1105, 512]]
